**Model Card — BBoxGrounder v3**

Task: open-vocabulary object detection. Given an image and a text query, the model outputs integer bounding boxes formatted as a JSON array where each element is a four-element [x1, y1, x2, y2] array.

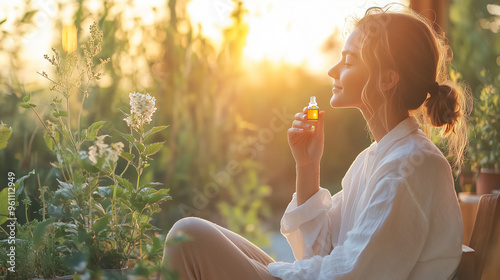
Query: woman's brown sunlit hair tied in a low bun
[[355, 4, 472, 167]]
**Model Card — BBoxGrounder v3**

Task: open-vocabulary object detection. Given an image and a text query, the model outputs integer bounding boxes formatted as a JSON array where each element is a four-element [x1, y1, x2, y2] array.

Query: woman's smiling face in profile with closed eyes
[[328, 28, 368, 111]]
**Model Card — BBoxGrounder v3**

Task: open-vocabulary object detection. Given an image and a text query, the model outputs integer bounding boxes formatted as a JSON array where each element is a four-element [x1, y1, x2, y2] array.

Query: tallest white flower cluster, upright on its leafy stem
[[123, 92, 157, 128]]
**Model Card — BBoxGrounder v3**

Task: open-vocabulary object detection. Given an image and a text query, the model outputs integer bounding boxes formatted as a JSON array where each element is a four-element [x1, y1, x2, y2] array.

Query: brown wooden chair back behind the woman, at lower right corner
[[456, 194, 500, 280]]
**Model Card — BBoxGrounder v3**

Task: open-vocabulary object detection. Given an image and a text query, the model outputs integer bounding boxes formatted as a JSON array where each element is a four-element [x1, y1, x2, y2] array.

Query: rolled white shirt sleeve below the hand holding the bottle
[[281, 188, 342, 260]]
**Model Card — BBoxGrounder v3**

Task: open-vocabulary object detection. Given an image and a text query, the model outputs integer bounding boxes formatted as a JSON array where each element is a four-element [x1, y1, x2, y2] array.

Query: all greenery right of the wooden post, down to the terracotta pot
[[447, 0, 500, 172]]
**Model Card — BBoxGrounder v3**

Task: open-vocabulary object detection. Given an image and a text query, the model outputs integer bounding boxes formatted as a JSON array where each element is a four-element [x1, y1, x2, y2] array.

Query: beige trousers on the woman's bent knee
[[163, 217, 279, 280]]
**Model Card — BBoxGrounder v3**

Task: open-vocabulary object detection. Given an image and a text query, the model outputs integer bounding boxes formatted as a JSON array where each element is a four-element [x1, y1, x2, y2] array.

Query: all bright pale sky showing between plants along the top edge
[[0, 0, 409, 82]]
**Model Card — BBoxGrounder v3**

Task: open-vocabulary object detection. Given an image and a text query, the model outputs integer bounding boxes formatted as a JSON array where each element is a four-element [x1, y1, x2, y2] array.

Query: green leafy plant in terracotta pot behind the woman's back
[[469, 70, 500, 195]]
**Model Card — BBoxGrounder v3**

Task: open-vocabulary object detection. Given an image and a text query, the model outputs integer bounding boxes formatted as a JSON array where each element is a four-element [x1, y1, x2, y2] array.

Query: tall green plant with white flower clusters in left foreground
[[17, 23, 170, 278]]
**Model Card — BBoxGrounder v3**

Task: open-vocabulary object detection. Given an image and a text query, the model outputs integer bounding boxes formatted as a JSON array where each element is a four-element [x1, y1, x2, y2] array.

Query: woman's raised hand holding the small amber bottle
[[288, 107, 325, 167]]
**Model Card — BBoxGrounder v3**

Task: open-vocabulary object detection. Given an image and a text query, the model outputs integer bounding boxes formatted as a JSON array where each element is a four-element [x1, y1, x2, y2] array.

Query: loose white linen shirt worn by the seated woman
[[268, 117, 462, 280]]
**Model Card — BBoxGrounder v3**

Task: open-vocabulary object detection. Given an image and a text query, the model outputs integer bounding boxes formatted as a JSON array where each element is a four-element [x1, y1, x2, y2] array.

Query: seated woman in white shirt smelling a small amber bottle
[[165, 5, 468, 280]]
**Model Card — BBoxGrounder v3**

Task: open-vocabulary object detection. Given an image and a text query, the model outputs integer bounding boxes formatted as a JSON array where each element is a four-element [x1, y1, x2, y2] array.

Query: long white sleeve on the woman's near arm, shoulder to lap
[[269, 177, 428, 280]]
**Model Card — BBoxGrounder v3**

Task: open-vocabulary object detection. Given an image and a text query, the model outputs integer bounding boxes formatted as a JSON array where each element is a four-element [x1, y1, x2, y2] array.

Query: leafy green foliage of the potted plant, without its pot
[[469, 70, 500, 170]]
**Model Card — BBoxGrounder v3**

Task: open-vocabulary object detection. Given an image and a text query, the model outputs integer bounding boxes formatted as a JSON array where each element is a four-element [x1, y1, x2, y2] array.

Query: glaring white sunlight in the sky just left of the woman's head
[[188, 0, 408, 73]]
